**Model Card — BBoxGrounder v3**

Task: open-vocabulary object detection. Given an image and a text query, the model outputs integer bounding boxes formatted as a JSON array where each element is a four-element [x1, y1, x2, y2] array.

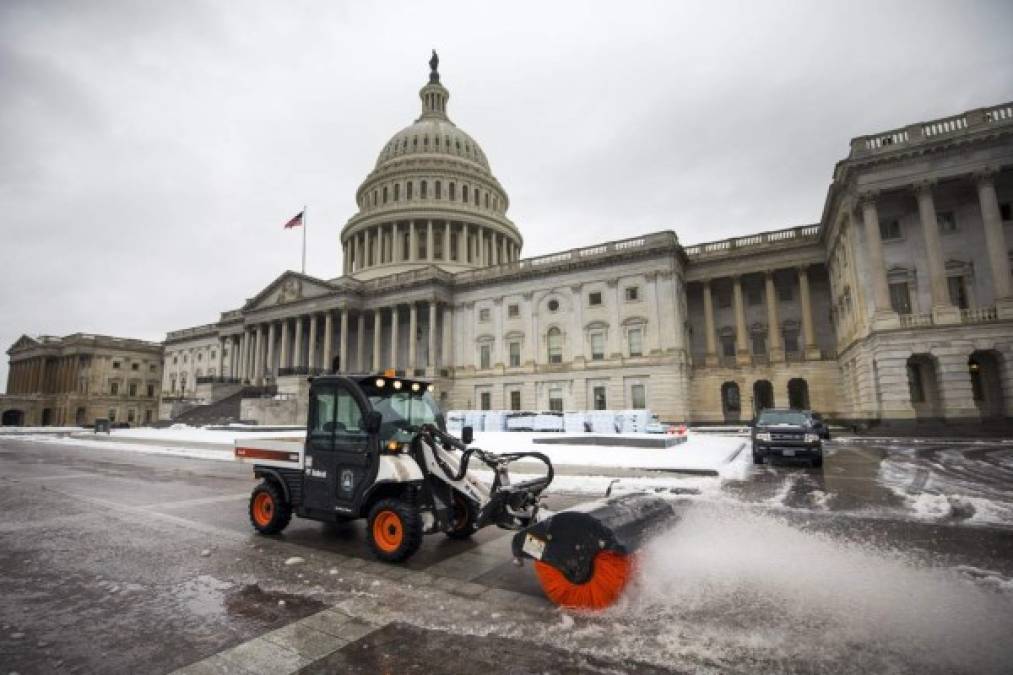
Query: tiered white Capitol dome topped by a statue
[[341, 52, 523, 279]]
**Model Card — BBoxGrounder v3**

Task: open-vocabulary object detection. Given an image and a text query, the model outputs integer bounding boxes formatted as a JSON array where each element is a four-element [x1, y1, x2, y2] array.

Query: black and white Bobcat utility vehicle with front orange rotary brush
[[235, 371, 675, 609]]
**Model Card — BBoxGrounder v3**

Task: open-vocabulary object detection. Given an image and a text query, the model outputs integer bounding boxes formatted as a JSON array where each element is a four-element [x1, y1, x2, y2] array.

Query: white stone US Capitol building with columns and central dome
[[149, 54, 1013, 423]]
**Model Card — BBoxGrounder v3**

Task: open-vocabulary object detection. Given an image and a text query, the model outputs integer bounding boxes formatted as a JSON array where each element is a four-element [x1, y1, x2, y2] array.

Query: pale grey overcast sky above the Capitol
[[0, 0, 1013, 387]]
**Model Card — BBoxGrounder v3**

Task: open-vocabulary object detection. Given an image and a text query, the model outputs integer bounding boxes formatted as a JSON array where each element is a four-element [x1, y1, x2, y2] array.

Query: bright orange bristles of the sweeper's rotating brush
[[535, 550, 633, 609]]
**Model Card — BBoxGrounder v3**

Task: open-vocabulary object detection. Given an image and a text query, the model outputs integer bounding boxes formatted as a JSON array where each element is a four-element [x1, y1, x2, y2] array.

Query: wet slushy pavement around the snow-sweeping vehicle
[[0, 439, 1013, 673]]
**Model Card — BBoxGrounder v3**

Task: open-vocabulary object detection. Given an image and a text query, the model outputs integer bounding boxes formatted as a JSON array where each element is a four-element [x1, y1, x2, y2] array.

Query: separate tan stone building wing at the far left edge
[[0, 332, 162, 426]]
